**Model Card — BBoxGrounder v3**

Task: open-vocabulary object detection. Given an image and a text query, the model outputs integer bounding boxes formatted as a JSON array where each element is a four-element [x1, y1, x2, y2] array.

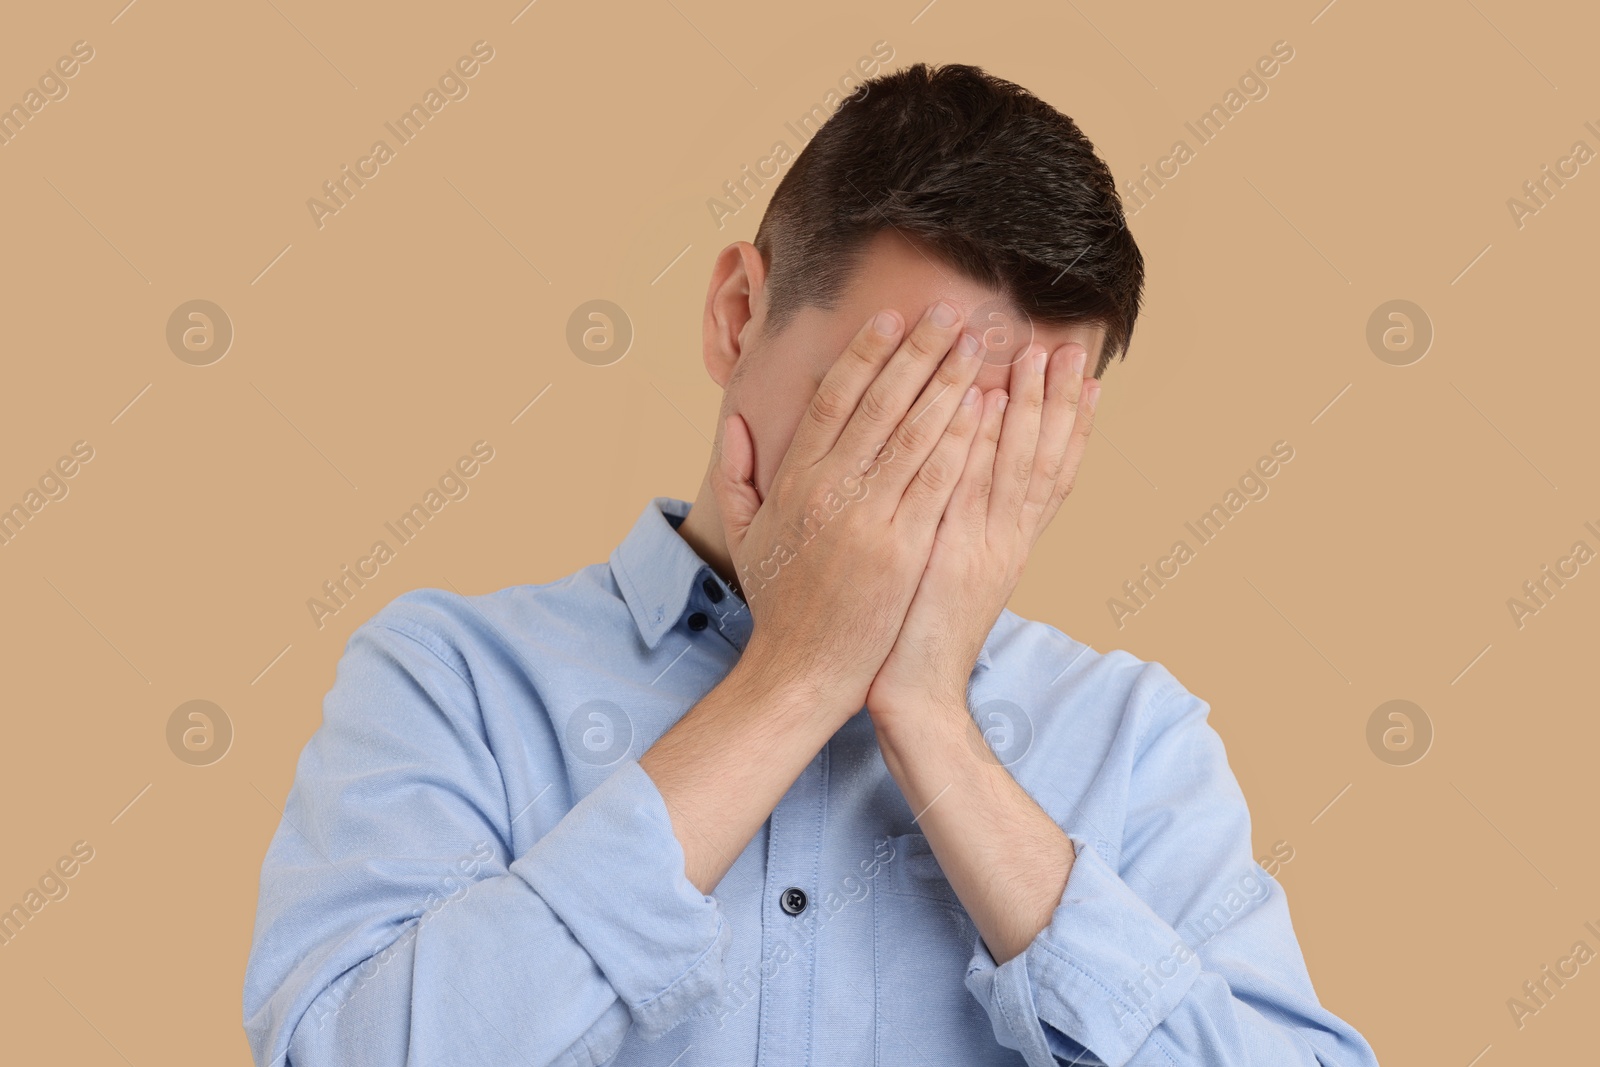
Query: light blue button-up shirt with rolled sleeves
[[243, 498, 1376, 1067]]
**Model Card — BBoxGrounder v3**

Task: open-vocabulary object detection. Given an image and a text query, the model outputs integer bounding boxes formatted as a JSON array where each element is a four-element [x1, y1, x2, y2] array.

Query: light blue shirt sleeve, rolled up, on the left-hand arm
[[243, 619, 730, 1067]]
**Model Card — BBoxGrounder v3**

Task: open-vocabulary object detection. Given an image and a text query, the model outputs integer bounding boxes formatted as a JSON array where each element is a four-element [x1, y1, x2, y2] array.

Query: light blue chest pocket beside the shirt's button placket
[[872, 833, 1022, 1067]]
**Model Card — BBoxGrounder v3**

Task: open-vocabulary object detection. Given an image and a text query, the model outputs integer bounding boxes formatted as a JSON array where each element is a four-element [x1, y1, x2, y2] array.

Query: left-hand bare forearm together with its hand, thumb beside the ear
[[638, 306, 982, 893]]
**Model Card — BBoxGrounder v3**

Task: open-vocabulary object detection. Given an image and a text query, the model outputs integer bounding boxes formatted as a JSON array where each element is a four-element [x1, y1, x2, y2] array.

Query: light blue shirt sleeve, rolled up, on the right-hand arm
[[966, 689, 1378, 1067]]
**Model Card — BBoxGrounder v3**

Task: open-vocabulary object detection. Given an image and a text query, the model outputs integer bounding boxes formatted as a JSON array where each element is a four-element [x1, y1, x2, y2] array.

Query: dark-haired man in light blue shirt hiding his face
[[245, 64, 1376, 1067]]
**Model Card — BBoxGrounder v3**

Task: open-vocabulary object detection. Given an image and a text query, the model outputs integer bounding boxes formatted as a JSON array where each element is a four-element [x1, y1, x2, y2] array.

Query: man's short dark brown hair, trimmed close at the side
[[755, 62, 1144, 376]]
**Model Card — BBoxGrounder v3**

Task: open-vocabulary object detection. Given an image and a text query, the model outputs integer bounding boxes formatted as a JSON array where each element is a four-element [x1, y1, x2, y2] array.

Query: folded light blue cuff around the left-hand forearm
[[510, 760, 731, 1040]]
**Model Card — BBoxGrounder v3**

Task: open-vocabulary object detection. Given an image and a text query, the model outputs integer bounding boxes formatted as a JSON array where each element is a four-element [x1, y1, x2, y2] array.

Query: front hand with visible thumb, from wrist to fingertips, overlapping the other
[[712, 302, 984, 715]]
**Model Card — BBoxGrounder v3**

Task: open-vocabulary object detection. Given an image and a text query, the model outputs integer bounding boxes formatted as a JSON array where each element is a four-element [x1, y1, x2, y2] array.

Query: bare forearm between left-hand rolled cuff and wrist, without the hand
[[638, 646, 861, 894]]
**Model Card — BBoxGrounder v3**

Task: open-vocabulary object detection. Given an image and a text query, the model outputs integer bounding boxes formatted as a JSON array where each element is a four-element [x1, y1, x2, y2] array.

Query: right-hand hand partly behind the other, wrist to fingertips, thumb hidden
[[867, 342, 1099, 726]]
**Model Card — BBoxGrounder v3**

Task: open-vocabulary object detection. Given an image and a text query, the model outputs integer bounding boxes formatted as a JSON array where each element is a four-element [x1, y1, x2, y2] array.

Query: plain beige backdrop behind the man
[[0, 0, 1600, 1067]]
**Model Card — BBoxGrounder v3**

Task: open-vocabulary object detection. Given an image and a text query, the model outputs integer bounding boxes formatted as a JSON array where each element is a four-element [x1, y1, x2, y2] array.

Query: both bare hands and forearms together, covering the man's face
[[640, 294, 1093, 902]]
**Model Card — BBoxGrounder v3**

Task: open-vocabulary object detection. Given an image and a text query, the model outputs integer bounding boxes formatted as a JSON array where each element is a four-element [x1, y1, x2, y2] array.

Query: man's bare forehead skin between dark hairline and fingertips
[[780, 229, 1106, 389]]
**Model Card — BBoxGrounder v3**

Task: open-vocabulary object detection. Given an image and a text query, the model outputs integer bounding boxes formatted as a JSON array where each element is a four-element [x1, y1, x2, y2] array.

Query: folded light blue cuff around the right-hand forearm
[[966, 837, 1202, 1067]]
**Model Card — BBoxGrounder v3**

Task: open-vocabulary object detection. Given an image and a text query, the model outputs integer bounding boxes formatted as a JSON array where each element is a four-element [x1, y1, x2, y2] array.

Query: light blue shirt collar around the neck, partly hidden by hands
[[611, 496, 994, 670]]
